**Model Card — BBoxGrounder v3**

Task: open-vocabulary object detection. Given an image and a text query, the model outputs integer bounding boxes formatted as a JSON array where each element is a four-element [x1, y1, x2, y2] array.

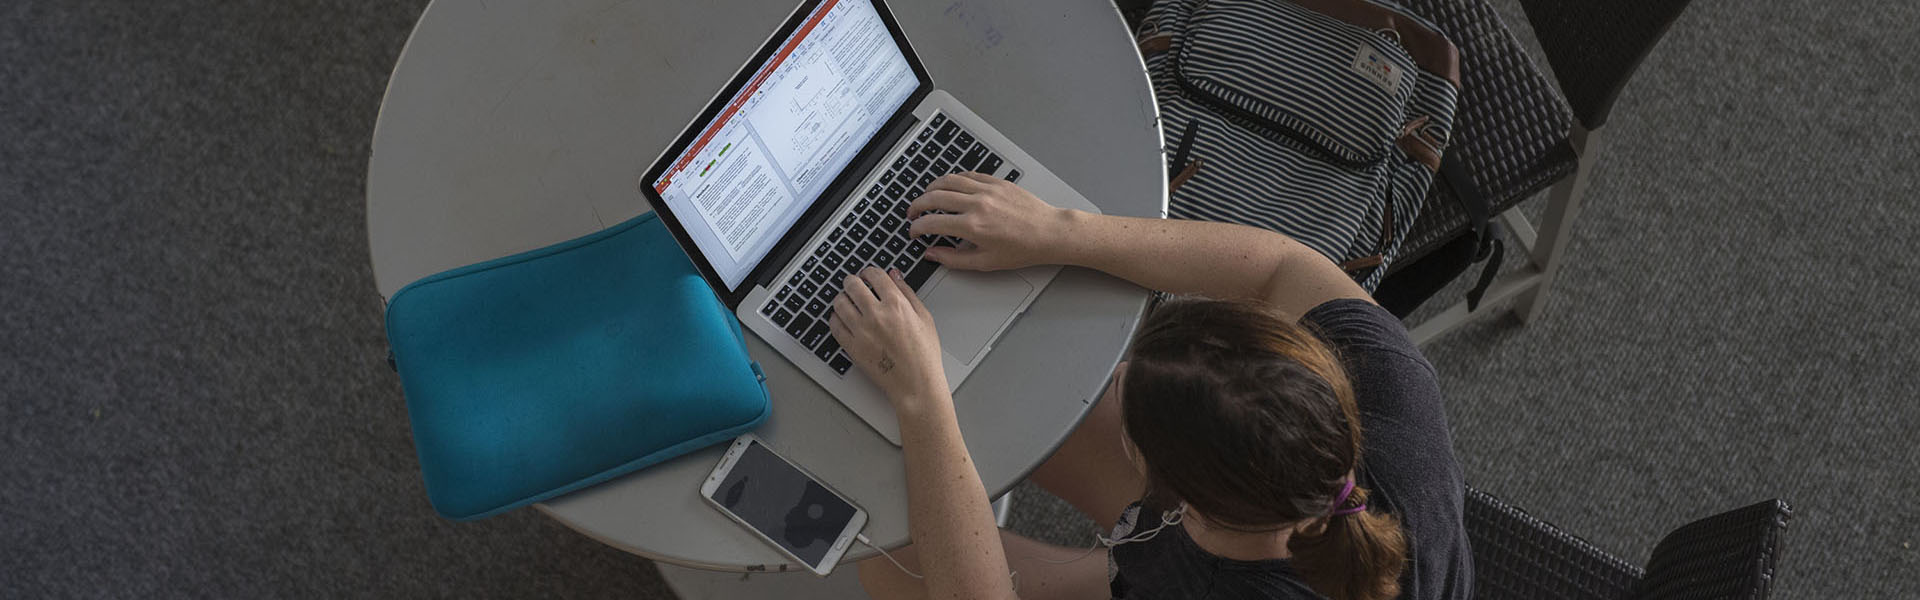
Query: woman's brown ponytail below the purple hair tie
[[1286, 488, 1407, 600]]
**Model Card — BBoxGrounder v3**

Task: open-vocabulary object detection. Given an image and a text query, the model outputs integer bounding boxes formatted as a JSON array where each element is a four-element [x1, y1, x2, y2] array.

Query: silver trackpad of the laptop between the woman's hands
[[922, 269, 1033, 365]]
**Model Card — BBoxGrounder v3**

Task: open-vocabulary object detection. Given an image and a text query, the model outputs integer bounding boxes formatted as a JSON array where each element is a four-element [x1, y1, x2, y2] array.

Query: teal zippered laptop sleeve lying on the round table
[[386, 213, 770, 521]]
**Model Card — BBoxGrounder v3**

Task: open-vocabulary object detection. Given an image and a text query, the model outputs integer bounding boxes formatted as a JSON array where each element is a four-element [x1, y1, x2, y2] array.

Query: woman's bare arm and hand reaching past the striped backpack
[[906, 173, 1371, 317]]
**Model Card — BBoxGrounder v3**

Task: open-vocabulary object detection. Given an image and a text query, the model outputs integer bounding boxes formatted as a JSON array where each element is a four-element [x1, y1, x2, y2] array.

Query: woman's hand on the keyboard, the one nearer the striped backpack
[[906, 173, 1073, 271]]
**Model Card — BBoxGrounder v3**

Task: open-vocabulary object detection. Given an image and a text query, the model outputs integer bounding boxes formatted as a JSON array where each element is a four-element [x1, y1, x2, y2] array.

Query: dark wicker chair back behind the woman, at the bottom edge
[[1467, 488, 1793, 600]]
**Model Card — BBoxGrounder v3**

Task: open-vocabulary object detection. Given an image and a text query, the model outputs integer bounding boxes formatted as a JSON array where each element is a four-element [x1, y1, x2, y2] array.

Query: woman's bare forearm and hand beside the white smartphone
[[829, 267, 1014, 598]]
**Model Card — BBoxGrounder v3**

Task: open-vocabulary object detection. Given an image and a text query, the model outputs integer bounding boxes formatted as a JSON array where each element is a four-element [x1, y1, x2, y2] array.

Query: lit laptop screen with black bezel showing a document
[[647, 0, 920, 290]]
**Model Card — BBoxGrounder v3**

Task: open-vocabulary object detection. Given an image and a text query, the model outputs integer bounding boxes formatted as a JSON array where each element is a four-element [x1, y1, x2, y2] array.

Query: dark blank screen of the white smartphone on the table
[[712, 440, 856, 567]]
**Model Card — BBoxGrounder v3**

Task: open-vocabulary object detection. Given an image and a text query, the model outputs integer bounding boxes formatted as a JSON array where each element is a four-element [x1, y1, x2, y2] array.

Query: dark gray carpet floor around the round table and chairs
[[0, 0, 1920, 598]]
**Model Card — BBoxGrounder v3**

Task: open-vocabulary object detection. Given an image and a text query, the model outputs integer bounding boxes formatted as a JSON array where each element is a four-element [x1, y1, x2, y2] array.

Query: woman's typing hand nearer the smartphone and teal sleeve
[[829, 267, 952, 417]]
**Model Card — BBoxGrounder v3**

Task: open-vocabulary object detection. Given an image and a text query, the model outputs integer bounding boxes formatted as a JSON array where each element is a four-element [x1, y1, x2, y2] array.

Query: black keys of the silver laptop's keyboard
[[760, 113, 1020, 375]]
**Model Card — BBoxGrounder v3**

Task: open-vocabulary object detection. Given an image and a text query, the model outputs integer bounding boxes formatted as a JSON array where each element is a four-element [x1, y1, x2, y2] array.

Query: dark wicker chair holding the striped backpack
[[1382, 0, 1686, 342]]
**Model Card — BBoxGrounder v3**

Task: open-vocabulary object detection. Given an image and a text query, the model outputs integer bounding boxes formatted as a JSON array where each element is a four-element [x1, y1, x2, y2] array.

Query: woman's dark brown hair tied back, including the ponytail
[[1119, 298, 1405, 600]]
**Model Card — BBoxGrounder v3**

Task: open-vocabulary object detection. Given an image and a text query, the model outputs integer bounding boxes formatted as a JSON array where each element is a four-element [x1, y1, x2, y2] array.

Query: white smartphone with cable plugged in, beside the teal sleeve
[[701, 433, 866, 577]]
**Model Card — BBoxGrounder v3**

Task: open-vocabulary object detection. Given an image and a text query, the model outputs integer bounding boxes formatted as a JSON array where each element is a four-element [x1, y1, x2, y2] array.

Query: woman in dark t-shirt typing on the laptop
[[831, 173, 1473, 600]]
